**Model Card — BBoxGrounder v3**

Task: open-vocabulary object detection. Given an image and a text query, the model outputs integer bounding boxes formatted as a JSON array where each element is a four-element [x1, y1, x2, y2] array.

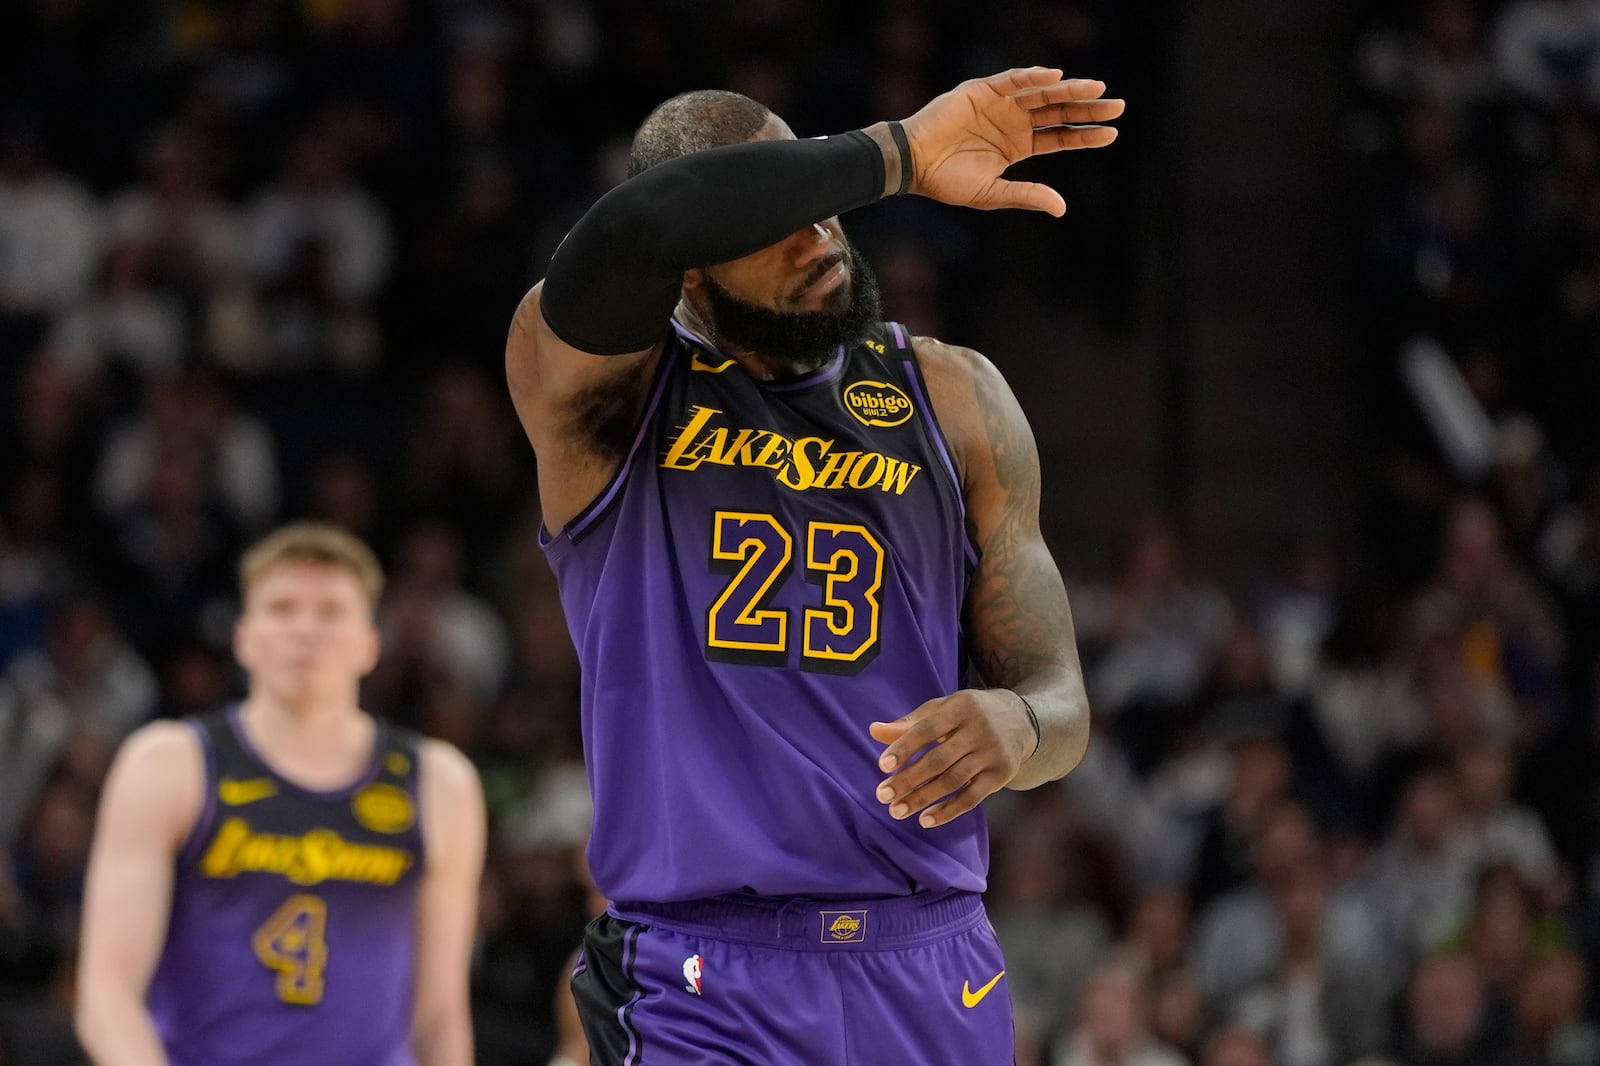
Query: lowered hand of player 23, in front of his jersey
[[867, 688, 1035, 829]]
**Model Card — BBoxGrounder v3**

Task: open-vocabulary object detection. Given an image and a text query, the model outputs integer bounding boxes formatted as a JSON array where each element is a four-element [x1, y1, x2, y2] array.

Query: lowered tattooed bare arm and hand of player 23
[[872, 338, 1090, 826]]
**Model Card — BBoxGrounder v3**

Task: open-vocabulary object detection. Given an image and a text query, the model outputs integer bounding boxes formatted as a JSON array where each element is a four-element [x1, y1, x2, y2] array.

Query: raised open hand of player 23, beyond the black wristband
[[901, 67, 1123, 218]]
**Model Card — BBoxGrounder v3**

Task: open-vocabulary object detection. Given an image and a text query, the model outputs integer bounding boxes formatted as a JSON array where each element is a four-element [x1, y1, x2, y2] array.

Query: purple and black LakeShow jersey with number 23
[[544, 323, 987, 901]]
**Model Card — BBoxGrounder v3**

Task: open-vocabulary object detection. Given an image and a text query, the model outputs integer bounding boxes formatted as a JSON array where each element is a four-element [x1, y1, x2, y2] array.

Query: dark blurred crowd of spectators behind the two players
[[0, 0, 1600, 1066]]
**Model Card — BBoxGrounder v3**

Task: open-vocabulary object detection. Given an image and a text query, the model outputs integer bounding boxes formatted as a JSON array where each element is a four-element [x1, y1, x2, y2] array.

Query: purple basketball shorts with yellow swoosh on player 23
[[573, 893, 1014, 1066]]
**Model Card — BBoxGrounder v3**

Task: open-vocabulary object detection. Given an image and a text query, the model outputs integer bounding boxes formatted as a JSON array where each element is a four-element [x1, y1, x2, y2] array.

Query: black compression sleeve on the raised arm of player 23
[[541, 130, 885, 355]]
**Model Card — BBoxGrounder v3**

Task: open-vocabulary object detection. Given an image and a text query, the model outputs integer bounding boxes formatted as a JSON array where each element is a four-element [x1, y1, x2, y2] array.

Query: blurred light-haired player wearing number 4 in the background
[[77, 523, 485, 1066]]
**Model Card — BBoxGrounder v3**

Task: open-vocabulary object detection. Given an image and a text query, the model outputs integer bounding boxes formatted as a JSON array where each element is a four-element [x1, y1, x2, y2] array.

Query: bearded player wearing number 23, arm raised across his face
[[507, 67, 1122, 1066]]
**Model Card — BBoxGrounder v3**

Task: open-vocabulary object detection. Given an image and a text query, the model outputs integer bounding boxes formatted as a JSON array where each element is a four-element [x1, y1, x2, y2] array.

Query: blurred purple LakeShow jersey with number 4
[[149, 707, 422, 1066]]
